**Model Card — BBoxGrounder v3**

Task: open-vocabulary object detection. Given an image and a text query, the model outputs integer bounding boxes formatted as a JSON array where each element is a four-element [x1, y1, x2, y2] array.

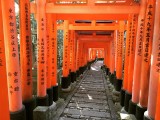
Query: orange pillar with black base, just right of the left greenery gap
[[61, 20, 71, 90]]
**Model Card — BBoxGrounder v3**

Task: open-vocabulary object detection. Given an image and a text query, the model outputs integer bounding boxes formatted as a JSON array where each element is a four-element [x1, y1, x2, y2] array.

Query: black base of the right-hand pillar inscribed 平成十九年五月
[[136, 105, 147, 120]]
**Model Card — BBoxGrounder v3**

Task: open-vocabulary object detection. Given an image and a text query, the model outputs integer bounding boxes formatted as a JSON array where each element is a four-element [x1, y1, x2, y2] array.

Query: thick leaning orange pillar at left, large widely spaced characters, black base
[[1, 0, 25, 120]]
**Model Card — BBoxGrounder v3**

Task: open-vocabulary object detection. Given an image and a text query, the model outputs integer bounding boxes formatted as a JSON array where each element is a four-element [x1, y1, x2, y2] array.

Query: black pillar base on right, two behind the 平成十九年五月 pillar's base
[[124, 91, 132, 112]]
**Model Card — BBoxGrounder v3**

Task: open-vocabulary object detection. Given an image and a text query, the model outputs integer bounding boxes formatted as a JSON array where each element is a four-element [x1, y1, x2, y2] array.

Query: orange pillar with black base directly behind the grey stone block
[[36, 0, 48, 106]]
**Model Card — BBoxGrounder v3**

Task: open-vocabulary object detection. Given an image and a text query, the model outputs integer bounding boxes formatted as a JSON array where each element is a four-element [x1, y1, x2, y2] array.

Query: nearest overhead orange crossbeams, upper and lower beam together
[[30, 0, 140, 20]]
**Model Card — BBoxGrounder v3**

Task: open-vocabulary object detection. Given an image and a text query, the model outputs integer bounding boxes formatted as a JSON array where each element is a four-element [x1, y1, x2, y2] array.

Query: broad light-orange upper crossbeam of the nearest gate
[[31, 2, 140, 14]]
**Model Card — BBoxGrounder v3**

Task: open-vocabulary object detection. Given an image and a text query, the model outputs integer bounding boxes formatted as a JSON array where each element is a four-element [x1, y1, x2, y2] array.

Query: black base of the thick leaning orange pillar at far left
[[10, 106, 26, 120]]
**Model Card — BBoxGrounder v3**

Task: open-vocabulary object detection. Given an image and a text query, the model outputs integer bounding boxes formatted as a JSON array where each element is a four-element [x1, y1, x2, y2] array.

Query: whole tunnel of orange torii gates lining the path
[[0, 0, 160, 120]]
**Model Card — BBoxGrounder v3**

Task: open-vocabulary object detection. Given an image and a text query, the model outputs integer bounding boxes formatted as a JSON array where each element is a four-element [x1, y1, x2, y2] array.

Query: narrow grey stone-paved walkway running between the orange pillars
[[60, 62, 115, 120]]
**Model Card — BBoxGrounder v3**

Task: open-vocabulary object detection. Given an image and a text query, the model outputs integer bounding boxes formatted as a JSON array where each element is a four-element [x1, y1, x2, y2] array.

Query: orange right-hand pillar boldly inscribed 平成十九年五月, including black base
[[136, 0, 155, 120]]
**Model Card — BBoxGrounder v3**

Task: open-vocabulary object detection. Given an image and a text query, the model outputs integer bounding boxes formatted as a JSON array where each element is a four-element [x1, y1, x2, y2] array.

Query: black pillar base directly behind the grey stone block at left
[[36, 95, 48, 106]]
